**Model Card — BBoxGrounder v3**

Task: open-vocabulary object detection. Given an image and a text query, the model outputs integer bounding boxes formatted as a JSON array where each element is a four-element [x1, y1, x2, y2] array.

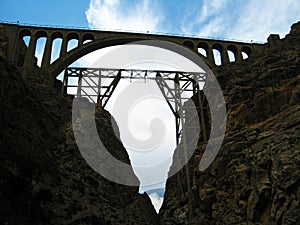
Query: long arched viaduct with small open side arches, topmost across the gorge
[[0, 23, 263, 84]]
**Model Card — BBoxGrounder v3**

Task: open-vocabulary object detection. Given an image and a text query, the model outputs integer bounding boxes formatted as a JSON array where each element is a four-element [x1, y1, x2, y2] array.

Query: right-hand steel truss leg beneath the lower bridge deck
[[156, 72, 204, 216]]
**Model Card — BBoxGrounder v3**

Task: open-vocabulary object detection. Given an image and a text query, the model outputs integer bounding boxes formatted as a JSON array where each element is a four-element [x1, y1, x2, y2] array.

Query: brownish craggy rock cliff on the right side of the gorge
[[160, 23, 300, 225]]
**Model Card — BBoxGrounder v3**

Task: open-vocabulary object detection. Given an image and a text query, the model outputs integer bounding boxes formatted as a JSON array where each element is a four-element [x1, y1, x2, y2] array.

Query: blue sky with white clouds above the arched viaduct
[[0, 0, 300, 213]]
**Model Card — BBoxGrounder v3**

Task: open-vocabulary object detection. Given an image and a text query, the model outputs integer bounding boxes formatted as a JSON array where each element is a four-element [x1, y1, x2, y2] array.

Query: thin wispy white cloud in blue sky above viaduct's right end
[[181, 0, 300, 42]]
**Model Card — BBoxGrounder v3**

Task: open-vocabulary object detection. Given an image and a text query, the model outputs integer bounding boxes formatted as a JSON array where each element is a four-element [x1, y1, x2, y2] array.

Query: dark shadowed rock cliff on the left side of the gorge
[[0, 57, 159, 225]]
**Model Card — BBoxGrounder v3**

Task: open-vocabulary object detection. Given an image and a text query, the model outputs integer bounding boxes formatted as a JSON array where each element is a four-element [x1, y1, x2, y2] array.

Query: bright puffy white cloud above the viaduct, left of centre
[[86, 0, 162, 32]]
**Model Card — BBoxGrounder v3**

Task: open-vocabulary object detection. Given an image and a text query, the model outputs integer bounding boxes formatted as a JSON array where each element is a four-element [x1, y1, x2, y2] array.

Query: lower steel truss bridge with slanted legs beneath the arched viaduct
[[62, 68, 207, 215]]
